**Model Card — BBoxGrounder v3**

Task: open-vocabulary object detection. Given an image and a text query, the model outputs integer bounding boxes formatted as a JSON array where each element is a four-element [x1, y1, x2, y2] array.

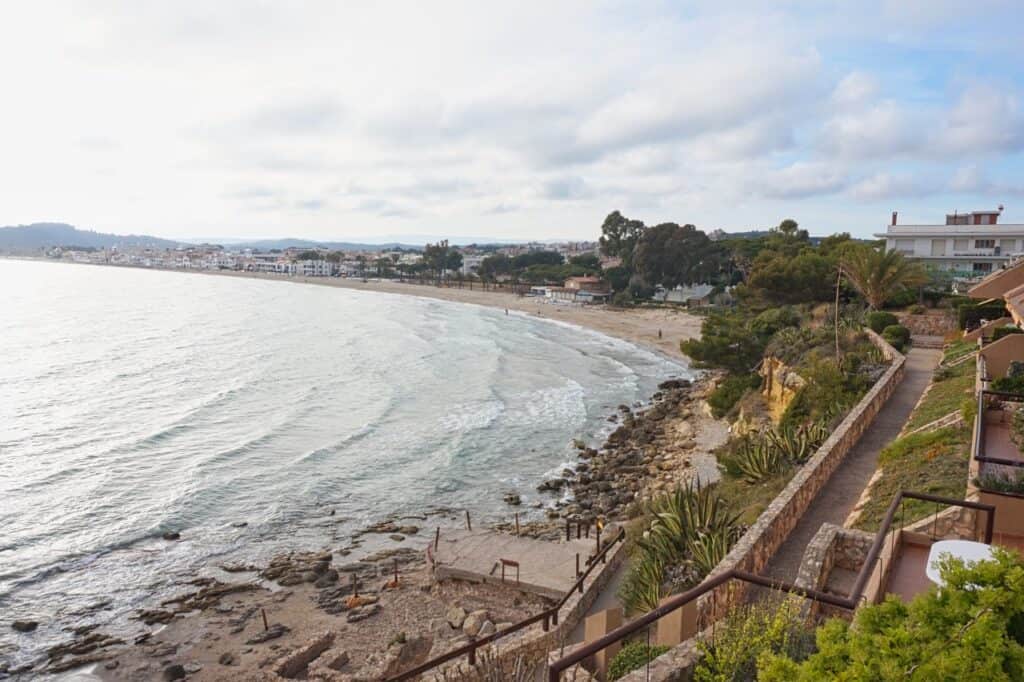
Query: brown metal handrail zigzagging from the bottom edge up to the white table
[[548, 491, 995, 682]]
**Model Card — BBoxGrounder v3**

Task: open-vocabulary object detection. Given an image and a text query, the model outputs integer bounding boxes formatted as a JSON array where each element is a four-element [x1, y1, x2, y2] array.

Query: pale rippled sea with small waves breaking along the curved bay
[[0, 259, 691, 667]]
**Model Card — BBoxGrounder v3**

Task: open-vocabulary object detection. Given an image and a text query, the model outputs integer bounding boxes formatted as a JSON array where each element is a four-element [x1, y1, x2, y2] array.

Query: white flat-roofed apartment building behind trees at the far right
[[874, 206, 1024, 273]]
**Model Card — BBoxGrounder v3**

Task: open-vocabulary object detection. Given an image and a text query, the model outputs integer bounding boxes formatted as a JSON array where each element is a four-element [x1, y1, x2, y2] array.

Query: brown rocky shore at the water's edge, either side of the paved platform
[[8, 375, 728, 681]]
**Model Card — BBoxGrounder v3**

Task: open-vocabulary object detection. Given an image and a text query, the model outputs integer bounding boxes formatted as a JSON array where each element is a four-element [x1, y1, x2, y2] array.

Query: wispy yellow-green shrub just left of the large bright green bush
[[693, 595, 814, 682]]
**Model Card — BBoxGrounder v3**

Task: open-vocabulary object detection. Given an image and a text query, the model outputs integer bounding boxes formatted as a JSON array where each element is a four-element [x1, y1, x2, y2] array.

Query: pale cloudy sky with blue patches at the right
[[0, 0, 1024, 241]]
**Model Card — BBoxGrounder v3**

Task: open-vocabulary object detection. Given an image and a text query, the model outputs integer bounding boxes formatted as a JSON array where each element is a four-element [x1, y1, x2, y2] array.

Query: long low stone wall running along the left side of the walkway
[[699, 330, 906, 627]]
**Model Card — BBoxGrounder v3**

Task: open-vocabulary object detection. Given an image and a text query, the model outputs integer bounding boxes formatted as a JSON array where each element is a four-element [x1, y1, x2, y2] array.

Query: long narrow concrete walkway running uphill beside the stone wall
[[762, 347, 942, 581]]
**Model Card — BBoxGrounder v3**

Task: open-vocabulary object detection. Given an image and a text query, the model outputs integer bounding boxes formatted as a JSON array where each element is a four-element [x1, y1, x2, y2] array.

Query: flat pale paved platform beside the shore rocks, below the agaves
[[435, 528, 617, 599]]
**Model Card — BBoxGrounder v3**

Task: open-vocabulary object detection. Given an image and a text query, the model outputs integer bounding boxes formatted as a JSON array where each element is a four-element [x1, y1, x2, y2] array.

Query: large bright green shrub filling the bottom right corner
[[757, 549, 1024, 682]]
